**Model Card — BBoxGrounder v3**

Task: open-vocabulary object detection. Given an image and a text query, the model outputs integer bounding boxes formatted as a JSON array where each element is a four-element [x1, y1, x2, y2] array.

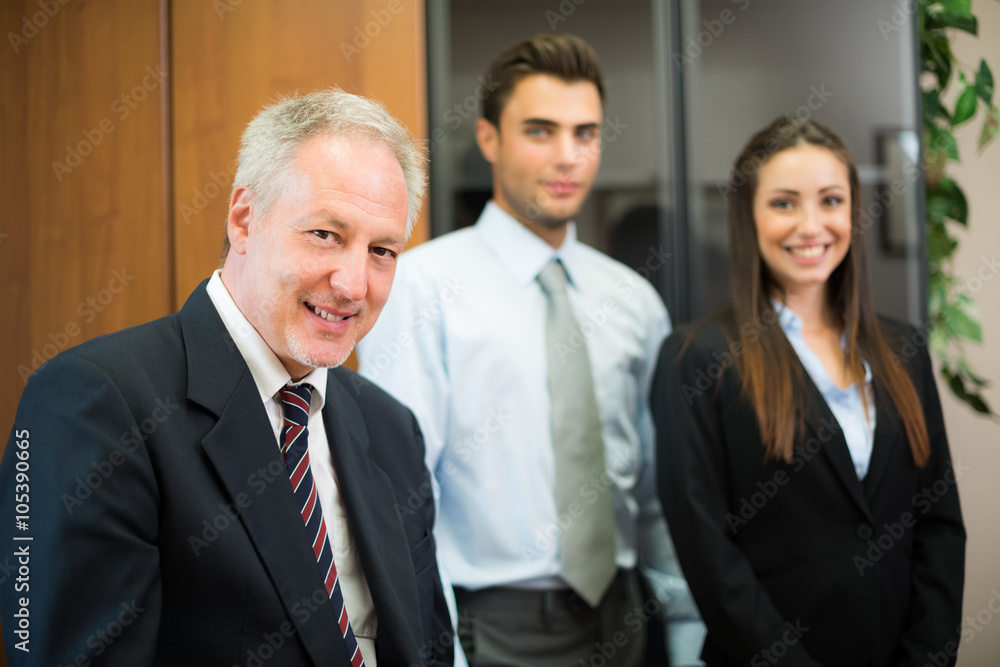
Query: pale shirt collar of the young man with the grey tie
[[476, 199, 582, 285]]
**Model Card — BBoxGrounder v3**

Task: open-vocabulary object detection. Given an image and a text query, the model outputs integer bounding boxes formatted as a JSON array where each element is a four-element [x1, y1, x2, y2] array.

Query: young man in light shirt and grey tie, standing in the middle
[[359, 35, 702, 667]]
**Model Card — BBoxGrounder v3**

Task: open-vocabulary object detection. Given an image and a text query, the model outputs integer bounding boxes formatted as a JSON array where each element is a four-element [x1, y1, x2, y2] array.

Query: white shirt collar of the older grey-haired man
[[207, 270, 327, 412]]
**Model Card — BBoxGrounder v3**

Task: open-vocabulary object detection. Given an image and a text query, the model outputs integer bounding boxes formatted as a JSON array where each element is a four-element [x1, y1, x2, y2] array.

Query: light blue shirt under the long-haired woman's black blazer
[[772, 301, 875, 479]]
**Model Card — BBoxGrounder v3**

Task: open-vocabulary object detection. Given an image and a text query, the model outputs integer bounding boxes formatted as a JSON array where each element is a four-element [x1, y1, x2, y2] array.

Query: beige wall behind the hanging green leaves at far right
[[938, 0, 1000, 667]]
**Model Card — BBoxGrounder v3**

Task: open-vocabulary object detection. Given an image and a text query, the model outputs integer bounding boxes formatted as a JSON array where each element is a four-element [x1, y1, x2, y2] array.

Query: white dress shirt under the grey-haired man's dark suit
[[207, 271, 378, 667]]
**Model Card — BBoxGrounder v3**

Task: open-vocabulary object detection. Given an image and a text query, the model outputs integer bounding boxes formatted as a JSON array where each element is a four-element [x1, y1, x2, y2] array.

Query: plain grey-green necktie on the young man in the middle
[[538, 260, 616, 607]]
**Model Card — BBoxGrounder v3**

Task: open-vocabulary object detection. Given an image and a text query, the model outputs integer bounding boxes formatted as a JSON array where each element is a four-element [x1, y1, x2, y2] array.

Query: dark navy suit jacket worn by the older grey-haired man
[[0, 283, 452, 667]]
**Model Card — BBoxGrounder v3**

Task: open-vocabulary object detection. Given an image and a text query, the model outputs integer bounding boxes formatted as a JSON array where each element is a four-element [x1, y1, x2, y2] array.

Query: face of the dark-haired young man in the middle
[[476, 74, 603, 241]]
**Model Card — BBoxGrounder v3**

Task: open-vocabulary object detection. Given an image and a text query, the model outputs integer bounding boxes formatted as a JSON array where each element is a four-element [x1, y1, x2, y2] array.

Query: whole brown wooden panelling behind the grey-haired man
[[0, 0, 427, 667]]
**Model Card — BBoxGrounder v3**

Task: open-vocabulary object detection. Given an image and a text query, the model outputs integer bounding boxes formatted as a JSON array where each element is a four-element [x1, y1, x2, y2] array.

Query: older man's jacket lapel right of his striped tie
[[323, 373, 419, 665]]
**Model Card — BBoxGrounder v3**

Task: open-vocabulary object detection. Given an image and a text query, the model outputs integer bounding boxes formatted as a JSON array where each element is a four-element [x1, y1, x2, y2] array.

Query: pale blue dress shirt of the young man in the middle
[[358, 202, 703, 664]]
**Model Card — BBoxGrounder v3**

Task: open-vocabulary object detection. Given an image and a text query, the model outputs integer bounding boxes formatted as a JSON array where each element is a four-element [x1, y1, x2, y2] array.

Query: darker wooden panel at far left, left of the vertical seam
[[0, 0, 170, 442]]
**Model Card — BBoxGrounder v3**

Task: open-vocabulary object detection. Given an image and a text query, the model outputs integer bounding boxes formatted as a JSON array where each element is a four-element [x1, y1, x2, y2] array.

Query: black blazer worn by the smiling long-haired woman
[[651, 314, 965, 667]]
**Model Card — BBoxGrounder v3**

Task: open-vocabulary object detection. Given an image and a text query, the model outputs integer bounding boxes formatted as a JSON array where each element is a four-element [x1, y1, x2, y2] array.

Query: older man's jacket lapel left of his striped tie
[[181, 283, 350, 665]]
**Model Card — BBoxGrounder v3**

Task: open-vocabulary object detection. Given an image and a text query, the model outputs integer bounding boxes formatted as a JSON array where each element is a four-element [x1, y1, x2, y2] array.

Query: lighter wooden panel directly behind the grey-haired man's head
[[171, 0, 426, 307]]
